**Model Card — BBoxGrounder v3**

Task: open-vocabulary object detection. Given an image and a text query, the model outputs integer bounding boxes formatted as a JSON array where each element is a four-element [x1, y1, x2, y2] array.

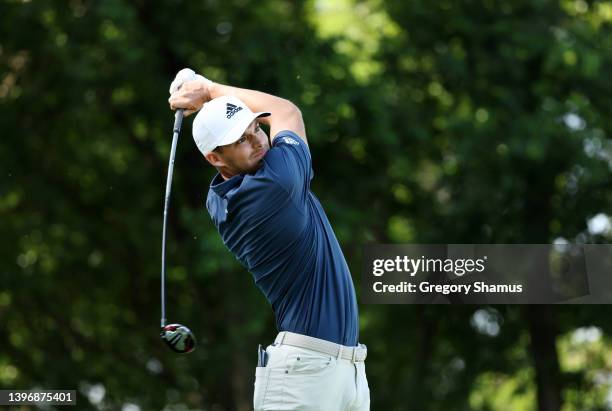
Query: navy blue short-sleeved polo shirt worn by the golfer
[[206, 131, 359, 346]]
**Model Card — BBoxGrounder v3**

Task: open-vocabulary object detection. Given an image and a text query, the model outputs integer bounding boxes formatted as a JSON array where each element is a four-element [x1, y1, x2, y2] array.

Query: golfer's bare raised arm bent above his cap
[[168, 80, 308, 144]]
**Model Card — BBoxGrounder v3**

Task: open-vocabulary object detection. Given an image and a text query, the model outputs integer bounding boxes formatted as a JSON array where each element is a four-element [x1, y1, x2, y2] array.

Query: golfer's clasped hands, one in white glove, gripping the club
[[168, 69, 214, 116]]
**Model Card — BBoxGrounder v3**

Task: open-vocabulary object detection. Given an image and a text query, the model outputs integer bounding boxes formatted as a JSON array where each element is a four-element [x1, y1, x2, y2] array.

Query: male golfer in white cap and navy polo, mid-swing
[[169, 69, 370, 411]]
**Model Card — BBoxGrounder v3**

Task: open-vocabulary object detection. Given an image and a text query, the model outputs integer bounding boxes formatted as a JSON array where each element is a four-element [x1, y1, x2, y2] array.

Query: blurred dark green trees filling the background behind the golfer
[[0, 0, 612, 411]]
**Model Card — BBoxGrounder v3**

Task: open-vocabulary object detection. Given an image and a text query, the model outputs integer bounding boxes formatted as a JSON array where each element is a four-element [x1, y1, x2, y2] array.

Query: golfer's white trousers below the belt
[[253, 344, 370, 411]]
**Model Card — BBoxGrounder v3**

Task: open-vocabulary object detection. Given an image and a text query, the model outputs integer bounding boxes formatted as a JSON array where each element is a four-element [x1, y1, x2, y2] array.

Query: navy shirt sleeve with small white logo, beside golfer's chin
[[264, 130, 314, 203]]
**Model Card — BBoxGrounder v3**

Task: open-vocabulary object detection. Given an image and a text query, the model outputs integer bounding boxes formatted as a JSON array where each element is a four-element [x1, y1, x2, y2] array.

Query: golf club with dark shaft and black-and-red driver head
[[161, 109, 196, 354]]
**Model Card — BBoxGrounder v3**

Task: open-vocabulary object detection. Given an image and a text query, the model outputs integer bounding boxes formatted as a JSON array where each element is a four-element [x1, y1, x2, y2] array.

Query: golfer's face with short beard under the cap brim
[[206, 120, 270, 178]]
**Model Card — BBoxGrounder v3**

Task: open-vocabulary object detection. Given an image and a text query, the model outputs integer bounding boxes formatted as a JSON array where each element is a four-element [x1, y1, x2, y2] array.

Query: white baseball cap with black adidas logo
[[192, 96, 270, 155]]
